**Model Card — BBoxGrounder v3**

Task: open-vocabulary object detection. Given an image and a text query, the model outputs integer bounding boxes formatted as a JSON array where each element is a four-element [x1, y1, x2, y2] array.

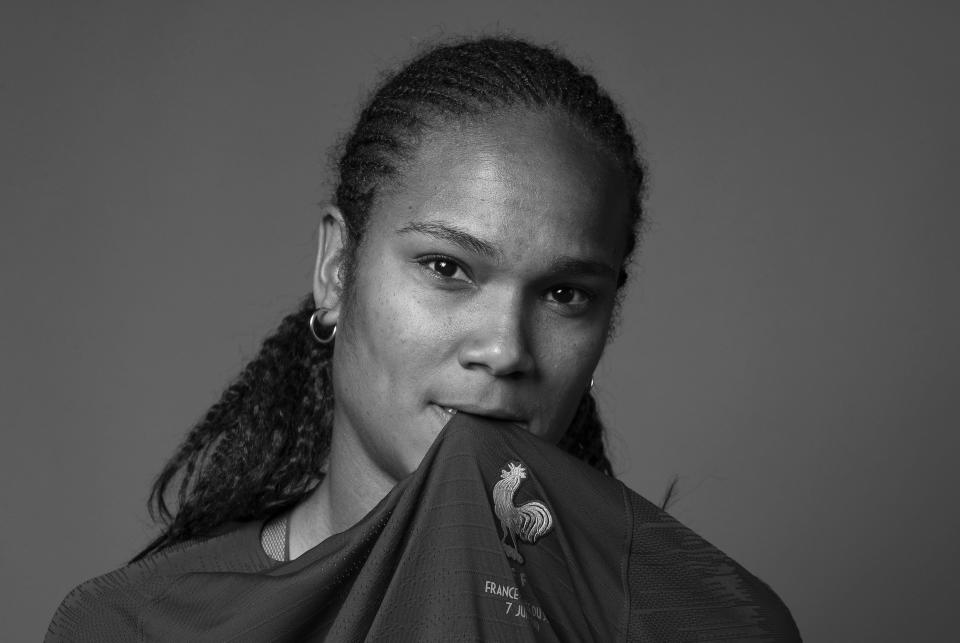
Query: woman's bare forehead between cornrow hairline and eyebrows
[[370, 111, 630, 263]]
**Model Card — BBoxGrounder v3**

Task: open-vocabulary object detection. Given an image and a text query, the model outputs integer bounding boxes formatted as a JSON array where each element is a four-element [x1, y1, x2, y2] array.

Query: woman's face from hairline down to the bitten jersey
[[333, 112, 630, 480]]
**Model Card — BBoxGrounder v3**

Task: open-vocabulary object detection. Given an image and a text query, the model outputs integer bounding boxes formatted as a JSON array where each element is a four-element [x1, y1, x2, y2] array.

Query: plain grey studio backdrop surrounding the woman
[[0, 1, 960, 641]]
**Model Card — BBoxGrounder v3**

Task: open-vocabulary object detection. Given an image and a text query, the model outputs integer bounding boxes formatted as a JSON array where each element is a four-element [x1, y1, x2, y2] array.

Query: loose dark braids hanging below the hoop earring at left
[[132, 295, 333, 558]]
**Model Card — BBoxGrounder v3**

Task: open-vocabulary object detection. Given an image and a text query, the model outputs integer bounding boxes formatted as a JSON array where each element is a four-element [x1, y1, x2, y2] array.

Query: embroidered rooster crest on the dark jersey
[[493, 462, 553, 565]]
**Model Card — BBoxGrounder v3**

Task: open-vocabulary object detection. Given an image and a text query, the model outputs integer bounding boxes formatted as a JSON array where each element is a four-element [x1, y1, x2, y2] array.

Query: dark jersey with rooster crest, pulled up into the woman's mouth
[[47, 414, 800, 642]]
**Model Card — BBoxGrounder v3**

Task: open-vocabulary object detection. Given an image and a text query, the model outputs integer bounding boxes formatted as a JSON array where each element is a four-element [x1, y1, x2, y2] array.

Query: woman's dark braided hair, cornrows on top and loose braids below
[[135, 38, 645, 560]]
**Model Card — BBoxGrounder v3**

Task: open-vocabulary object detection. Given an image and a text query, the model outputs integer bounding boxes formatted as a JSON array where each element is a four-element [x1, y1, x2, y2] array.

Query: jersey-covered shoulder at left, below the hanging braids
[[45, 521, 271, 643]]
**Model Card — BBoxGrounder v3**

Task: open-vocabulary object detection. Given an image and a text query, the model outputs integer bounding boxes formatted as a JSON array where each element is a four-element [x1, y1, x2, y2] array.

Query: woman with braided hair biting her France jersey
[[48, 39, 799, 640]]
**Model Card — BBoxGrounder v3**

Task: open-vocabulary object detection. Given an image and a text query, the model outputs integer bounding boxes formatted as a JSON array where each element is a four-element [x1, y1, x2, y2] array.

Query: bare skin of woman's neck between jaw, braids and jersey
[[289, 411, 397, 559]]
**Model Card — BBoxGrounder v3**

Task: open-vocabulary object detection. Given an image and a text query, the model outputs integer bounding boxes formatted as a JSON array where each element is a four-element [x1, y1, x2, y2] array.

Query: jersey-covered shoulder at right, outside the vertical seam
[[626, 490, 800, 641]]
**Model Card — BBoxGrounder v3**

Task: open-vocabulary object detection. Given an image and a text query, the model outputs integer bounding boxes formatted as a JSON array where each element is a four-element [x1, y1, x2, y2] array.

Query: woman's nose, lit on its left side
[[458, 302, 534, 377]]
